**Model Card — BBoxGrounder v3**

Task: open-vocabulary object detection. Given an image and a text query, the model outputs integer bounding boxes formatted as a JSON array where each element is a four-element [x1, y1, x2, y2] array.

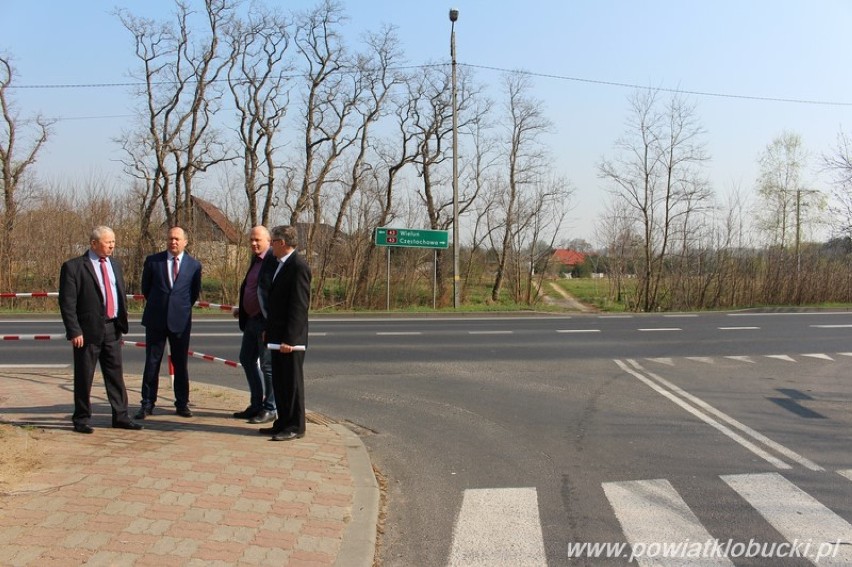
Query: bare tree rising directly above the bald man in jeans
[[228, 7, 293, 226]]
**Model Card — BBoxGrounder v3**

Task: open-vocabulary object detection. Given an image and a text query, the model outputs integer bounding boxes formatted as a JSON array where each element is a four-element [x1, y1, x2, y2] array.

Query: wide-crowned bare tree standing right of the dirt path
[[599, 91, 711, 311]]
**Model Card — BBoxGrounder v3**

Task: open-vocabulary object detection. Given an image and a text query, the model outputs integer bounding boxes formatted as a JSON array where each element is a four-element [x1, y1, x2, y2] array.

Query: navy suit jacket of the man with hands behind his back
[[142, 251, 201, 333]]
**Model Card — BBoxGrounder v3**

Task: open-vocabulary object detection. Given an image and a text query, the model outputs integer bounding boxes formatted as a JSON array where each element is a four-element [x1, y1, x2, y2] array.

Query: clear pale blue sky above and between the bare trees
[[0, 0, 852, 241]]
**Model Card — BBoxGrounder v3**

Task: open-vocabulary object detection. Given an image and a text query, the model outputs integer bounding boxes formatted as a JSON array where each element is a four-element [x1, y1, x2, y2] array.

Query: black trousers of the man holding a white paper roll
[[271, 350, 305, 433]]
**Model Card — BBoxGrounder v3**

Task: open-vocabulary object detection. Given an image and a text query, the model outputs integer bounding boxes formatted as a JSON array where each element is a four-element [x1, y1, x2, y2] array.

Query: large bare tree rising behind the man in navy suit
[[117, 0, 238, 253]]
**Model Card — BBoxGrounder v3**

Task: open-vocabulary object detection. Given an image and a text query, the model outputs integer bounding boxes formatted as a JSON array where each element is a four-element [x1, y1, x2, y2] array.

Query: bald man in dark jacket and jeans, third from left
[[234, 225, 278, 423]]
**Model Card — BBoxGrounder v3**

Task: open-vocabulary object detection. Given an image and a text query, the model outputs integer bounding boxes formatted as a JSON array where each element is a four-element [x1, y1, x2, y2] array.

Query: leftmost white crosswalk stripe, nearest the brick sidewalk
[[448, 488, 547, 567]]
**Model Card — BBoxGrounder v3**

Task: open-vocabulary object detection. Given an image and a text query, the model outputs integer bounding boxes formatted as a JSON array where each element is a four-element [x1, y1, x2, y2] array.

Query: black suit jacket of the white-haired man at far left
[[59, 252, 128, 344]]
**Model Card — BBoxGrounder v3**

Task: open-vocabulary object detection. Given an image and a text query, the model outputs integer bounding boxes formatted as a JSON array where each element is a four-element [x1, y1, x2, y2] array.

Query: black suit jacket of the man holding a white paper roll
[[266, 251, 311, 346]]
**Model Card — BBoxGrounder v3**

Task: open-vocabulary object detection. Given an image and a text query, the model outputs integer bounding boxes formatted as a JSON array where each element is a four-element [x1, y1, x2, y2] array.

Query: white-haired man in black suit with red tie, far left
[[59, 226, 142, 433]]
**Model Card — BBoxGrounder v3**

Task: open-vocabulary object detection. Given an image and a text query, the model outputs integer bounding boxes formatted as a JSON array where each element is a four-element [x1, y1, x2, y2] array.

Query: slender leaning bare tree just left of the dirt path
[[491, 73, 551, 301]]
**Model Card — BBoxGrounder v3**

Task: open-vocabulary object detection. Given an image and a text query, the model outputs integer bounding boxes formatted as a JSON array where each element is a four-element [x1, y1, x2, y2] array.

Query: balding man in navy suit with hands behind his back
[[135, 226, 201, 419]]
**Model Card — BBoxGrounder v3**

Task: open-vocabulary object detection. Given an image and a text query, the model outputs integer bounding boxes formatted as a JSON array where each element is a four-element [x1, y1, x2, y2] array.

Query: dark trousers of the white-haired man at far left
[[71, 322, 130, 425]]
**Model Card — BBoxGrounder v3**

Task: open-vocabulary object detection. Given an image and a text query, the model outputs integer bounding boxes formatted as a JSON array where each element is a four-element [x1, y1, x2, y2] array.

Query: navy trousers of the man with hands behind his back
[[142, 325, 191, 408]]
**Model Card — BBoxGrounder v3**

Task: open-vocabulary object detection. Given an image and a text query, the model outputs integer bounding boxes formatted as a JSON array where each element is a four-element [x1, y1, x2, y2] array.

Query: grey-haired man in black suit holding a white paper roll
[[260, 226, 311, 441]]
